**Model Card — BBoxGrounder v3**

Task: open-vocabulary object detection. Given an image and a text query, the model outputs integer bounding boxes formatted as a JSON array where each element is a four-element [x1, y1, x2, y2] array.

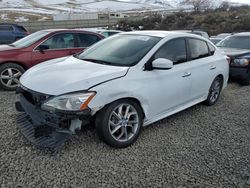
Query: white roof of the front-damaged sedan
[[120, 30, 205, 39]]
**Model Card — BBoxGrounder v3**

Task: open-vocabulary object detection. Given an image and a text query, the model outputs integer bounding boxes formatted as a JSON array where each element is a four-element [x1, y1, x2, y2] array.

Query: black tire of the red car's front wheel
[[0, 63, 25, 91]]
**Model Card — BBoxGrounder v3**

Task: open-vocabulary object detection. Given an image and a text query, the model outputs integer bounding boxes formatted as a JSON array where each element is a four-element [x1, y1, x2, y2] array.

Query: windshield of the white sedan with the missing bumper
[[77, 35, 161, 66]]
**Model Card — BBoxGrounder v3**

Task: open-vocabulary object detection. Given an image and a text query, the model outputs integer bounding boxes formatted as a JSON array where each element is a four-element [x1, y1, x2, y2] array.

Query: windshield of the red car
[[11, 31, 50, 48]]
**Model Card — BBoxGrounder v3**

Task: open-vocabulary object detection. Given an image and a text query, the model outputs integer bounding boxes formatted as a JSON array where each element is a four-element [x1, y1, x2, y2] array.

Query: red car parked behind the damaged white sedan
[[0, 29, 104, 90]]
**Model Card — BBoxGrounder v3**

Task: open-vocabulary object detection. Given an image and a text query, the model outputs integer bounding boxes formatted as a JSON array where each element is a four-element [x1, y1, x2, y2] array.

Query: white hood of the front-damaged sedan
[[20, 56, 129, 95]]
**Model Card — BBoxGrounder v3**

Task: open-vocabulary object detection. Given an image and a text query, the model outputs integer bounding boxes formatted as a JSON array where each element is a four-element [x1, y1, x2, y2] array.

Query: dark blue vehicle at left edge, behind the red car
[[0, 23, 29, 44]]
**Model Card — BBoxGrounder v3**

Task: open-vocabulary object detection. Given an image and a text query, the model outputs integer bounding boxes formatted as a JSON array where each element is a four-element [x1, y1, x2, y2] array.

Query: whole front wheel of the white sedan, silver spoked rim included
[[96, 99, 143, 148]]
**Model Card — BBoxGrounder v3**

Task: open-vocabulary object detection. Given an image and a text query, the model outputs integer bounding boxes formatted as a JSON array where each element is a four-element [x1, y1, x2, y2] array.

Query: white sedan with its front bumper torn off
[[16, 31, 229, 148]]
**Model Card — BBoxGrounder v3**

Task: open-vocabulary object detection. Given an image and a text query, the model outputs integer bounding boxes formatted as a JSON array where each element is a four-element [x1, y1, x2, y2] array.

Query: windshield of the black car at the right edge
[[216, 36, 250, 49]]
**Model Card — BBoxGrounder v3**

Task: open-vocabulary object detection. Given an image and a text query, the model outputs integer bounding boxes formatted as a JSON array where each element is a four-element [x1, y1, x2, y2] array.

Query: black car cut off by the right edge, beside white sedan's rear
[[217, 32, 250, 85]]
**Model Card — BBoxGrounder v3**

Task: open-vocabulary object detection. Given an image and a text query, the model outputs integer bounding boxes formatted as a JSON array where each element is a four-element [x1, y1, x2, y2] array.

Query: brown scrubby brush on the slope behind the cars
[[118, 6, 250, 35]]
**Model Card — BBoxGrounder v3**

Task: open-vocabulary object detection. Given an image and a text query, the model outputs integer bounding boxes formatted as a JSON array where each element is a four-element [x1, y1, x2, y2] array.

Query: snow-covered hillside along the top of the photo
[[0, 0, 249, 22]]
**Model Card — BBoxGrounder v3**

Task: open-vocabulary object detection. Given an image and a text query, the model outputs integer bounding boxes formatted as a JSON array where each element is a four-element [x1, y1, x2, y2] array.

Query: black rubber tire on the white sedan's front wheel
[[95, 99, 143, 148]]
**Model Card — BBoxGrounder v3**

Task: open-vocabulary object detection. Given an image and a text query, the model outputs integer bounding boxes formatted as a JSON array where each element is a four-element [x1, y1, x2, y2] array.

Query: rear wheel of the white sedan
[[205, 76, 223, 106]]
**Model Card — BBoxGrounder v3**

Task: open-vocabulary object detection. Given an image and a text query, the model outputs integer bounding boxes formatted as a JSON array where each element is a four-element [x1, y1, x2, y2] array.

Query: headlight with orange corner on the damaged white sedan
[[42, 92, 96, 111]]
